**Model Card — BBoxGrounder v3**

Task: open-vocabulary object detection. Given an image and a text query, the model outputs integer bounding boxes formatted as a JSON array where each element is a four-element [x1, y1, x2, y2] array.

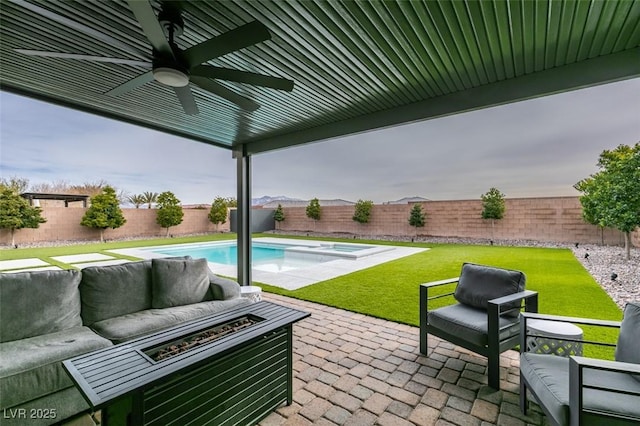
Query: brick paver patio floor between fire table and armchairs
[[260, 294, 547, 426]]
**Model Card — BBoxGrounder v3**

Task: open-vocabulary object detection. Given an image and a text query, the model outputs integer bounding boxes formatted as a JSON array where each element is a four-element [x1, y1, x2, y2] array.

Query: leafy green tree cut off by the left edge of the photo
[[0, 183, 47, 247]]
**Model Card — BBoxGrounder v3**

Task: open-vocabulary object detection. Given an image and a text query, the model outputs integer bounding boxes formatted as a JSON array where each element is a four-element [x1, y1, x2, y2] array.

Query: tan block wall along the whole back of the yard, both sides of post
[[0, 197, 640, 247]]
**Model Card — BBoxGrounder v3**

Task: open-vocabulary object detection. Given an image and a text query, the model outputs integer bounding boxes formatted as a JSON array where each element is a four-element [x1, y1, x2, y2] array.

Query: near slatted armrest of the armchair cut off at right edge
[[569, 356, 640, 425]]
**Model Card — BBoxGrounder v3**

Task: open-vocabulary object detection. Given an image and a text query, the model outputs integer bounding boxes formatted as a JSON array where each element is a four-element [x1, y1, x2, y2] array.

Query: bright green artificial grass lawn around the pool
[[0, 233, 622, 358]]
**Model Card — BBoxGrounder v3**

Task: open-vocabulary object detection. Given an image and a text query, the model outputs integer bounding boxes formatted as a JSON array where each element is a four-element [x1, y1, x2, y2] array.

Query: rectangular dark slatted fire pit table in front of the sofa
[[63, 301, 310, 426]]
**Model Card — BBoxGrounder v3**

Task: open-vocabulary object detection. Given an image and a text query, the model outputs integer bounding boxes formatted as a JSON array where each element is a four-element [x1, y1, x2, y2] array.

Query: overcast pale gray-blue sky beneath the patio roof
[[0, 79, 640, 204]]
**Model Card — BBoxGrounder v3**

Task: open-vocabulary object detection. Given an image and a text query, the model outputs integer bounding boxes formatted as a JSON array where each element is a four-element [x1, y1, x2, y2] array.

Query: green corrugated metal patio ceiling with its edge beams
[[0, 0, 640, 154]]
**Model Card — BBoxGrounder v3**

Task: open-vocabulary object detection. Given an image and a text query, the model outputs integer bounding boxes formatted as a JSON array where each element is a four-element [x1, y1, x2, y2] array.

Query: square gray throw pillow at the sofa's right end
[[151, 259, 210, 308]]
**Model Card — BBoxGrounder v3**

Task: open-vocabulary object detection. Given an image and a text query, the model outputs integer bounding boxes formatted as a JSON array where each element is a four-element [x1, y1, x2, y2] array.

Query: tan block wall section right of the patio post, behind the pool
[[278, 197, 640, 247]]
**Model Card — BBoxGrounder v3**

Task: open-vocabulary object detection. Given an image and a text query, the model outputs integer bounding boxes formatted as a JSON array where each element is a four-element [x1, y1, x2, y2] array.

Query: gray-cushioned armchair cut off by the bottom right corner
[[520, 302, 640, 426]]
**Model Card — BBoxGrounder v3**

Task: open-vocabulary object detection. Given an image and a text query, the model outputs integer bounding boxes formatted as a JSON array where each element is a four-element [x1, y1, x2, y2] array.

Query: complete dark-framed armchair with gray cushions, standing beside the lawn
[[420, 263, 538, 389]]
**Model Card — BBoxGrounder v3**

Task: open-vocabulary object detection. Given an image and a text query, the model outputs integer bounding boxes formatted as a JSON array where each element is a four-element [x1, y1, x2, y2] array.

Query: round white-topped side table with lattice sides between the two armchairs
[[527, 319, 582, 357]]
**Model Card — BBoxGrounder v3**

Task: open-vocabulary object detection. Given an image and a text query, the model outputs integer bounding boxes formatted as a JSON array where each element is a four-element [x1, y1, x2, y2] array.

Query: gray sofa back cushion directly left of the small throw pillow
[[80, 260, 151, 325]]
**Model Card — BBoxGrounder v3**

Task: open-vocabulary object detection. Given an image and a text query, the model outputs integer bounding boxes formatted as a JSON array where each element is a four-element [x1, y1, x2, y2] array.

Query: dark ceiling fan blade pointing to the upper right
[[183, 21, 271, 68]]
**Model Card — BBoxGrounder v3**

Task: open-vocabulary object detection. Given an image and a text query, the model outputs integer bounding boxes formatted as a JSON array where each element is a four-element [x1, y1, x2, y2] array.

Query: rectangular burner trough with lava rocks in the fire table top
[[142, 315, 264, 362]]
